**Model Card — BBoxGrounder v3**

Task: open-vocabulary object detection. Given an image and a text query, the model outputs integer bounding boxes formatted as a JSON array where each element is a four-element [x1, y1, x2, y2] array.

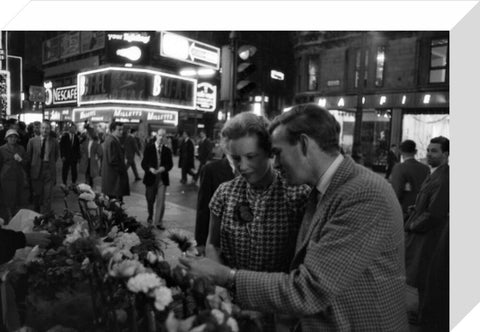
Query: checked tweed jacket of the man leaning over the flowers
[[235, 157, 408, 332]]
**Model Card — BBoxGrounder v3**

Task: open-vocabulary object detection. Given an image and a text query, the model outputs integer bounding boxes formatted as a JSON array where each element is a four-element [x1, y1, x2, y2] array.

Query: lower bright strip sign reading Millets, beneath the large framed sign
[[73, 107, 178, 126]]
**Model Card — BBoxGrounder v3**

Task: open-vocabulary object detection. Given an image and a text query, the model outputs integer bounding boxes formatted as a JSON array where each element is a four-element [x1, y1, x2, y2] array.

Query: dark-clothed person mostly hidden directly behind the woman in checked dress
[[195, 157, 235, 252]]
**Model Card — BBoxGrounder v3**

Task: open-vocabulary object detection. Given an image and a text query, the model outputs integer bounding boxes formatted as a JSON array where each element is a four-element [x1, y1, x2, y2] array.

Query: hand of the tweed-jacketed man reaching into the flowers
[[179, 257, 230, 287]]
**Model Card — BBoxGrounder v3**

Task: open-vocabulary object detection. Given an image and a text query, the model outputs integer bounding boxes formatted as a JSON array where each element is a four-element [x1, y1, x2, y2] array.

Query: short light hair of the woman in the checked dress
[[221, 112, 272, 153]]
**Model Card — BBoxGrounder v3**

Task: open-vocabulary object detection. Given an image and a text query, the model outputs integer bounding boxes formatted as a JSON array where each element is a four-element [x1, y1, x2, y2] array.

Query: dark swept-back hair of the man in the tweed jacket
[[269, 104, 340, 154]]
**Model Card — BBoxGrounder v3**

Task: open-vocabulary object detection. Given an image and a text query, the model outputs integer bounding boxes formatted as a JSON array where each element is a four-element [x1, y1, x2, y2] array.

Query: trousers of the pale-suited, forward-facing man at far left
[[32, 162, 55, 213]]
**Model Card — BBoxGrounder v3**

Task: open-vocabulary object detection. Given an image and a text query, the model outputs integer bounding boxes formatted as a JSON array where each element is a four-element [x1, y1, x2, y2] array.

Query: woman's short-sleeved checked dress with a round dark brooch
[[210, 173, 310, 272]]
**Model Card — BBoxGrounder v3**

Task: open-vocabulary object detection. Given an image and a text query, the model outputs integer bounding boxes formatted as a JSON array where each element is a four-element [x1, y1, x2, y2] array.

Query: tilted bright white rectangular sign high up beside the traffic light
[[160, 31, 220, 69]]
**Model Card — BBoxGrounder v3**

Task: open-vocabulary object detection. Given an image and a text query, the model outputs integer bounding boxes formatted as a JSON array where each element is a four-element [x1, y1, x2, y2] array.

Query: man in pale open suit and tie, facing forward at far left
[[27, 121, 60, 213]]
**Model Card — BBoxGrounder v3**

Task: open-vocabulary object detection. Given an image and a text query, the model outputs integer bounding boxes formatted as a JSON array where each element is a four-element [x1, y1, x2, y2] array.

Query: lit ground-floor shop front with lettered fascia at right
[[315, 91, 450, 171]]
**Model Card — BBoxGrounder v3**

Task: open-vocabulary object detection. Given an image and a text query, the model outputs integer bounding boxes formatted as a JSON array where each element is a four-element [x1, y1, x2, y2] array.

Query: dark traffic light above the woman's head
[[236, 45, 257, 100]]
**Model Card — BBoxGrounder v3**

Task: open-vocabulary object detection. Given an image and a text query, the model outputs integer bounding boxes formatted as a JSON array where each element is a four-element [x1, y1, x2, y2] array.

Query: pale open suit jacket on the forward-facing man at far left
[[27, 136, 60, 183]]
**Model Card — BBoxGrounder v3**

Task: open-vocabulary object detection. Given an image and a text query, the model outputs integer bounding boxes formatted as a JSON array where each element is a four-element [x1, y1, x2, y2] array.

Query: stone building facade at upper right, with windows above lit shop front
[[292, 31, 450, 170]]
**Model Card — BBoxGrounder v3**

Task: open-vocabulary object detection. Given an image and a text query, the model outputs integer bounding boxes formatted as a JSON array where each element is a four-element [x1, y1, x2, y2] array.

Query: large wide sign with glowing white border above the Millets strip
[[77, 67, 197, 110]]
